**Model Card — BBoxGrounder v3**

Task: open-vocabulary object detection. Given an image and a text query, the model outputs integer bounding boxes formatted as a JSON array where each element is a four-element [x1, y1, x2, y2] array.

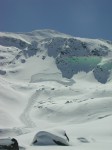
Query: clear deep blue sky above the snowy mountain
[[0, 0, 112, 41]]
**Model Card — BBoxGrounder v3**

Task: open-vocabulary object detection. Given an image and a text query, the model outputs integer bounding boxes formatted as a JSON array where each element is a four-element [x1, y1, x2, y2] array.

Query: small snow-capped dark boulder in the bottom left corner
[[0, 138, 19, 150]]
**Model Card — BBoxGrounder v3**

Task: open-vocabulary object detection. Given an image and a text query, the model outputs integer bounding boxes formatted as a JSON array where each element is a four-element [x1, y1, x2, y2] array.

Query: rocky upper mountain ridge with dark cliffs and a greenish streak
[[0, 29, 112, 83]]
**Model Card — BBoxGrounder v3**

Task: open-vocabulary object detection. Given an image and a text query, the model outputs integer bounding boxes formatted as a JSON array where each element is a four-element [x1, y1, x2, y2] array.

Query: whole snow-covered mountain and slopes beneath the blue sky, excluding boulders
[[0, 30, 112, 150]]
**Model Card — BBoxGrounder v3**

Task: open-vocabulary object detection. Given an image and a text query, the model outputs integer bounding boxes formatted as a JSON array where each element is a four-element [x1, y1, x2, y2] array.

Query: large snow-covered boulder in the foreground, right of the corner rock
[[32, 130, 69, 146]]
